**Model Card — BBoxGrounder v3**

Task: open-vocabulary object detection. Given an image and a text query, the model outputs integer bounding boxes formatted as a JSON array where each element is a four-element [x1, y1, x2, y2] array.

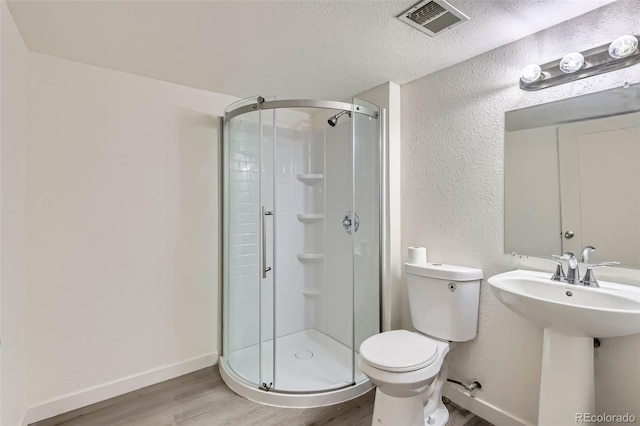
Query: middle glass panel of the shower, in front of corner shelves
[[274, 104, 360, 393]]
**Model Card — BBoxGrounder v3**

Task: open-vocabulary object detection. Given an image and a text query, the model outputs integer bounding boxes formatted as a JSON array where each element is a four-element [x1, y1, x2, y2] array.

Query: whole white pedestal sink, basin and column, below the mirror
[[488, 270, 640, 425]]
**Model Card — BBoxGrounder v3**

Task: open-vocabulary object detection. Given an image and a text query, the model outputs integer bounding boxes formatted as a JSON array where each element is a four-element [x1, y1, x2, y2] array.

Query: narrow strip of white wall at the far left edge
[[0, 1, 29, 426]]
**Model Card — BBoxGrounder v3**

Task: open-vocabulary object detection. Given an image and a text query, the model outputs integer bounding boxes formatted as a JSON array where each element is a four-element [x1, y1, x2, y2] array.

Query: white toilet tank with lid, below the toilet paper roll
[[404, 263, 482, 342]]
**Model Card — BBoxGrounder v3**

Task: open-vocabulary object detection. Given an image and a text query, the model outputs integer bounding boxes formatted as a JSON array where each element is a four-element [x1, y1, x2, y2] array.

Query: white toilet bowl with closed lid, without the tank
[[358, 330, 449, 426]]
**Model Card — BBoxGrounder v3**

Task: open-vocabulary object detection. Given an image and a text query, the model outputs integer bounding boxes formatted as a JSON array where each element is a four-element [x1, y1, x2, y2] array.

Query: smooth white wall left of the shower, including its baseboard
[[25, 54, 236, 421]]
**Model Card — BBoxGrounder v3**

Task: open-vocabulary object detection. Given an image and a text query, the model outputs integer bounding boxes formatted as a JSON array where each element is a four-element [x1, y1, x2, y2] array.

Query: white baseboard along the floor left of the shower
[[22, 352, 218, 426]]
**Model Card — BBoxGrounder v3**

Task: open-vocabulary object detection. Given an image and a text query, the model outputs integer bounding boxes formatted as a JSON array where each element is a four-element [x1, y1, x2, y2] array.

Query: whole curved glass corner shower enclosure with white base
[[220, 97, 384, 407]]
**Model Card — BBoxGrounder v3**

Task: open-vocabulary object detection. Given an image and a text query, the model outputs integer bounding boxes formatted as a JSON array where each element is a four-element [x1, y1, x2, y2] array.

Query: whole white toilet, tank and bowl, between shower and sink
[[358, 263, 482, 426]]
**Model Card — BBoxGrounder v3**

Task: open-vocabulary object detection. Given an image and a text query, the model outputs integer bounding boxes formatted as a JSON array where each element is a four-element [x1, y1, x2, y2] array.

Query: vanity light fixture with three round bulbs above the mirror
[[520, 35, 640, 90]]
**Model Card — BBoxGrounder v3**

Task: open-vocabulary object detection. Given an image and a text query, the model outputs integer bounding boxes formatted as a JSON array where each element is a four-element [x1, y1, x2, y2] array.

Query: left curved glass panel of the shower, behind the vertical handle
[[223, 98, 273, 387]]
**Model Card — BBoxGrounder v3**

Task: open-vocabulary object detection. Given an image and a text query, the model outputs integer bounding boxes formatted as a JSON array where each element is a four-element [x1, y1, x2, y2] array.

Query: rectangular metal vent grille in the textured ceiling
[[398, 0, 469, 37]]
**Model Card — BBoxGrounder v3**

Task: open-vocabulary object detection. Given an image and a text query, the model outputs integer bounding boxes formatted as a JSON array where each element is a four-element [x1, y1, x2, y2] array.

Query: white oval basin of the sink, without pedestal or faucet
[[489, 270, 640, 337]]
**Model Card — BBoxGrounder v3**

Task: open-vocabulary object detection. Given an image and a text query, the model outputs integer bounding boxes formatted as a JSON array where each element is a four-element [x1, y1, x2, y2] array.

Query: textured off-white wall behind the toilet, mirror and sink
[[402, 0, 640, 424]]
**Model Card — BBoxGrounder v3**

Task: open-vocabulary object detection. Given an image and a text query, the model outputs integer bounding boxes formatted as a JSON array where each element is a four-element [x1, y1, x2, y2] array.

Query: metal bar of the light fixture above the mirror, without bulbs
[[520, 35, 640, 90]]
